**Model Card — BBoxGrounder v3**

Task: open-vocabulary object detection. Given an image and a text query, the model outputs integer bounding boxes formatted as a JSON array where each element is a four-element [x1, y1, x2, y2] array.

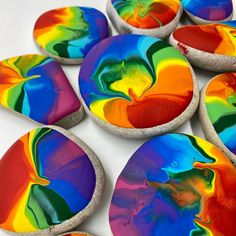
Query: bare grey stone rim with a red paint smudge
[[169, 34, 236, 72]]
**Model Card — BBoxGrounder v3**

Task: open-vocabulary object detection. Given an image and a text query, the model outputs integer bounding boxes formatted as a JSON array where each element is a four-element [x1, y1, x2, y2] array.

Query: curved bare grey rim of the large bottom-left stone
[[1, 125, 106, 236]]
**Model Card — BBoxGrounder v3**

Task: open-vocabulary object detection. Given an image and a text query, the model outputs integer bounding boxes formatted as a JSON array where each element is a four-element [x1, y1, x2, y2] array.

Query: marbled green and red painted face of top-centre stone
[[111, 0, 181, 29]]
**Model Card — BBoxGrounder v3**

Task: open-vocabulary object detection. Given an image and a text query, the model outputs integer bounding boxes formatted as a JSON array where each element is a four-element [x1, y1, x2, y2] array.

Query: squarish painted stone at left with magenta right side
[[0, 54, 83, 128]]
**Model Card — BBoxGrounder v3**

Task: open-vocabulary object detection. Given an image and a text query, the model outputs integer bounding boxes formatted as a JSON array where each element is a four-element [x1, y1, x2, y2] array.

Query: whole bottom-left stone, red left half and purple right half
[[0, 127, 105, 235]]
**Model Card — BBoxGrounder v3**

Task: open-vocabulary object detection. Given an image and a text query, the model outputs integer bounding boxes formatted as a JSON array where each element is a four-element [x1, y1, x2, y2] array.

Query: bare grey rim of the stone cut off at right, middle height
[[198, 77, 236, 166]]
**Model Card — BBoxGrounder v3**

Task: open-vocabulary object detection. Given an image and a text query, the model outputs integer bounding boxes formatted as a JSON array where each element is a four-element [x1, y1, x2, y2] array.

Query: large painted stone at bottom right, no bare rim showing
[[109, 134, 236, 236]]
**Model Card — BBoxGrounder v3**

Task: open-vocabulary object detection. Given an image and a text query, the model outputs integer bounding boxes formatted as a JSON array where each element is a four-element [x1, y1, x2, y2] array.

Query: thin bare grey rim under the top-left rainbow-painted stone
[[33, 37, 84, 65]]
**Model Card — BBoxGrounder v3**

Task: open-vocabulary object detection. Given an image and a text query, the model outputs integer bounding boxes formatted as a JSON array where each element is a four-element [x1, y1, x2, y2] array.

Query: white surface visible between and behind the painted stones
[[0, 0, 236, 236]]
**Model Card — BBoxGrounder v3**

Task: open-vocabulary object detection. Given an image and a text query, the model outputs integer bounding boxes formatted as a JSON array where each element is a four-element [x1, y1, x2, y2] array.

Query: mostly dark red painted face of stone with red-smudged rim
[[173, 20, 236, 56]]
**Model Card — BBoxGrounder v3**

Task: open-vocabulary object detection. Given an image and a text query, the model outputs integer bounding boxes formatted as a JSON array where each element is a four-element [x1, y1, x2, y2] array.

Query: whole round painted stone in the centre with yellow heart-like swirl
[[79, 35, 199, 138]]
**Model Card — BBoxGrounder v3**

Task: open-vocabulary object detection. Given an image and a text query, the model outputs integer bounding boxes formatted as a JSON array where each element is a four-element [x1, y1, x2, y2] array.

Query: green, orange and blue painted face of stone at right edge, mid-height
[[205, 73, 236, 155]]
